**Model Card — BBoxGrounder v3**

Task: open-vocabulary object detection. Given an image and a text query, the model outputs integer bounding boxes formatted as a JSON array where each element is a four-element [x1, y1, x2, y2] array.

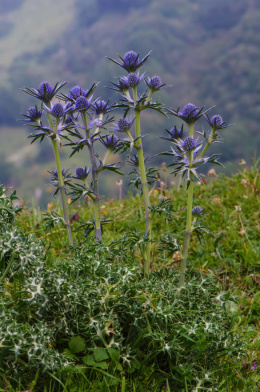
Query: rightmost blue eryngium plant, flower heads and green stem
[[163, 103, 230, 287]]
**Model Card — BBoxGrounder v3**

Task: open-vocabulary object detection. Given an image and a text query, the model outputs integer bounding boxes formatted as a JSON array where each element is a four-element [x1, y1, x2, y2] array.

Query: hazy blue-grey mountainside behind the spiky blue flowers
[[0, 0, 260, 207]]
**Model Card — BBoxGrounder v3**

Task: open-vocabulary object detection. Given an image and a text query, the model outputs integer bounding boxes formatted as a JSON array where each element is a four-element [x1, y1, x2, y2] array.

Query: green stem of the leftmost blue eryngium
[[52, 138, 73, 245]]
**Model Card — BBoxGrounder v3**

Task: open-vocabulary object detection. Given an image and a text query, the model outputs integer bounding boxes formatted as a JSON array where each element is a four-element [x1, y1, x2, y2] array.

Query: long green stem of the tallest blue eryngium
[[133, 87, 152, 276]]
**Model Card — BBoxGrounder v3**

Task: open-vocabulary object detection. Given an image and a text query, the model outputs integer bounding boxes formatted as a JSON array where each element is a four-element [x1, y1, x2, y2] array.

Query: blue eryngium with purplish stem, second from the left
[[60, 83, 121, 242]]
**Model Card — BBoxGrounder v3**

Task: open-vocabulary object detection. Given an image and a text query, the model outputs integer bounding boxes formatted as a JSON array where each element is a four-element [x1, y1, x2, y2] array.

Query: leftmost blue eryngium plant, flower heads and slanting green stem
[[23, 82, 73, 245]]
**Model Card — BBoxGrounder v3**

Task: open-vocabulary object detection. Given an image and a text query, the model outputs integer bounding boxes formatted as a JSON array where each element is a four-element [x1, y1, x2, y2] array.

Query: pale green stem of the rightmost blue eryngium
[[179, 124, 194, 287]]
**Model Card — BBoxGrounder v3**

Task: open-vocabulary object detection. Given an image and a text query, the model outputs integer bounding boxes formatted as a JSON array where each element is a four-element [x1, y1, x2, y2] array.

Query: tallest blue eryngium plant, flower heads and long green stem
[[109, 51, 165, 276]]
